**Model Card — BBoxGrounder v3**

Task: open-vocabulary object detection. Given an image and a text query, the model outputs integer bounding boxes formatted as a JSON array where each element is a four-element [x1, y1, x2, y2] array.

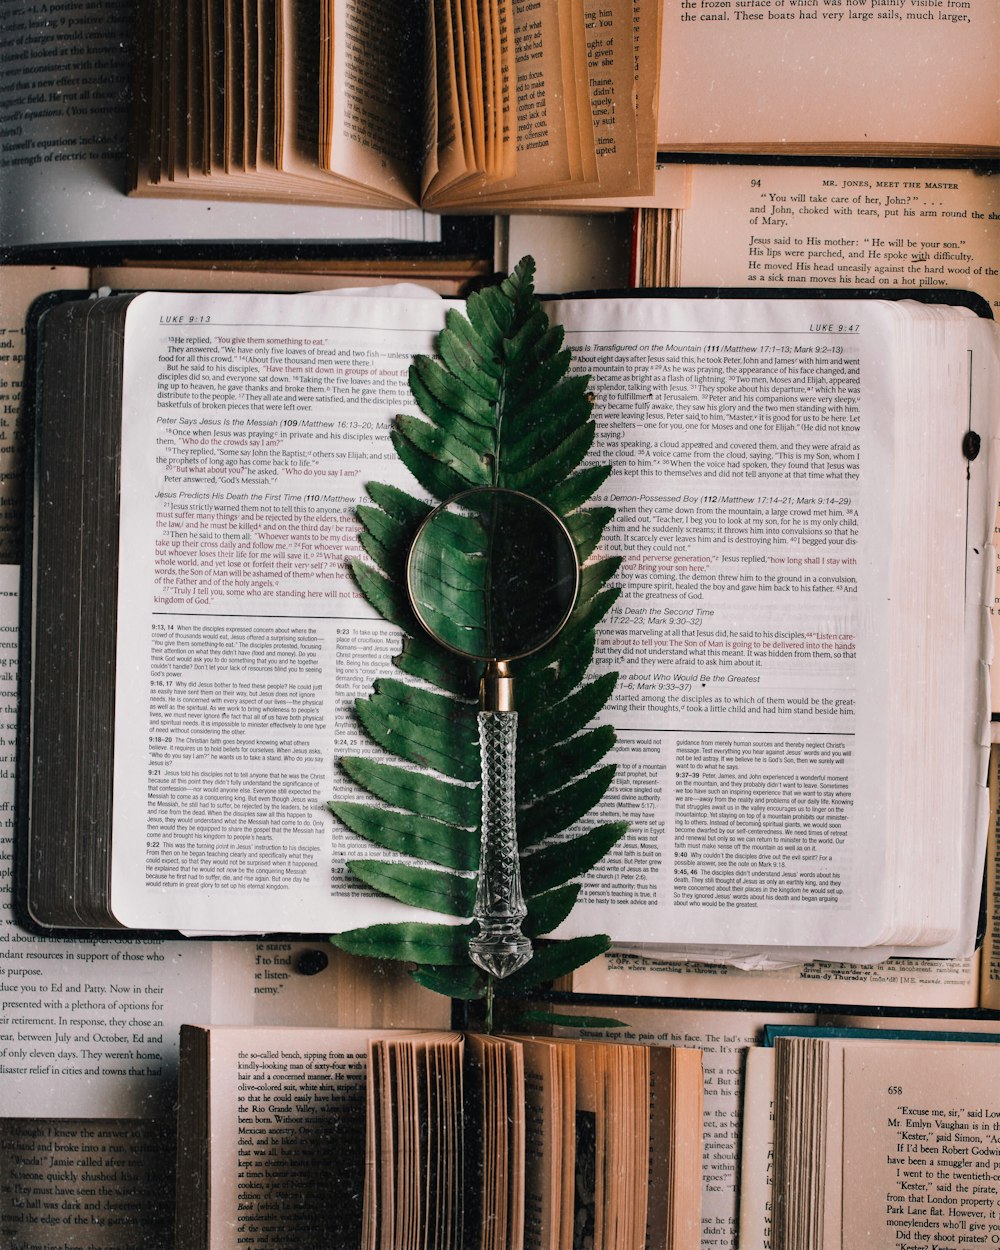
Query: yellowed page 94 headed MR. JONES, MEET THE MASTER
[[674, 164, 1000, 315]]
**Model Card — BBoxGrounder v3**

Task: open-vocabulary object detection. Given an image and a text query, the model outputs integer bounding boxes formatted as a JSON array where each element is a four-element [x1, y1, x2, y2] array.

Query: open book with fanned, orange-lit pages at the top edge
[[131, 0, 660, 213]]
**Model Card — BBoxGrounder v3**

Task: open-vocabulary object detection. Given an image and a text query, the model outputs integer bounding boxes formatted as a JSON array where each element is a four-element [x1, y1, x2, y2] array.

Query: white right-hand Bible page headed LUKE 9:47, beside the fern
[[553, 299, 900, 946]]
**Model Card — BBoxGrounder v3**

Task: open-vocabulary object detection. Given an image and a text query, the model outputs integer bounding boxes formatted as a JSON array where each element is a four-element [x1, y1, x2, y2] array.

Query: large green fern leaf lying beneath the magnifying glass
[[329, 258, 624, 1015]]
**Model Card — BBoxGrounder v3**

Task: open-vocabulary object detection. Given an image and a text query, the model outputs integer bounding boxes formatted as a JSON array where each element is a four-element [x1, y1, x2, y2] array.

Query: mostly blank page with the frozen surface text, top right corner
[[658, 0, 1000, 153]]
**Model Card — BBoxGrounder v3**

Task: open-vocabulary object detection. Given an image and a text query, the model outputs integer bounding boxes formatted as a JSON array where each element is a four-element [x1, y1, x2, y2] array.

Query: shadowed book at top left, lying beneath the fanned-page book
[[0, 0, 490, 256]]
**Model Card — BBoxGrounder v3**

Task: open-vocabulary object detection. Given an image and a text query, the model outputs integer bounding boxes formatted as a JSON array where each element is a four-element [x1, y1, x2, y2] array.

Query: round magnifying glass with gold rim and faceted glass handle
[[406, 486, 580, 978]]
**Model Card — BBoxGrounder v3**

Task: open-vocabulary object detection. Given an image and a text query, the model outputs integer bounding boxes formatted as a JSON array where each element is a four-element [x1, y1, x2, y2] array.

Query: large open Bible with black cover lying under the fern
[[21, 283, 998, 959]]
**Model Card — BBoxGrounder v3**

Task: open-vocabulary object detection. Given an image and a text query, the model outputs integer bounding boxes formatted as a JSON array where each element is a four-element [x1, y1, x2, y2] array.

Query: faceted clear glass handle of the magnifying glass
[[469, 711, 531, 978]]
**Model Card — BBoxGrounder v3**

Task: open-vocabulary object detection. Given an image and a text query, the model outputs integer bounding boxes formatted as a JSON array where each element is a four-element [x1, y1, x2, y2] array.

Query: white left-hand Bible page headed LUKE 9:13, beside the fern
[[113, 294, 457, 933]]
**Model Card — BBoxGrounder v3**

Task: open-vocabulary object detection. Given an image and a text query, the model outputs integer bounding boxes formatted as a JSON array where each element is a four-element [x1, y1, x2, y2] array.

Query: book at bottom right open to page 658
[[740, 1021, 1000, 1250]]
